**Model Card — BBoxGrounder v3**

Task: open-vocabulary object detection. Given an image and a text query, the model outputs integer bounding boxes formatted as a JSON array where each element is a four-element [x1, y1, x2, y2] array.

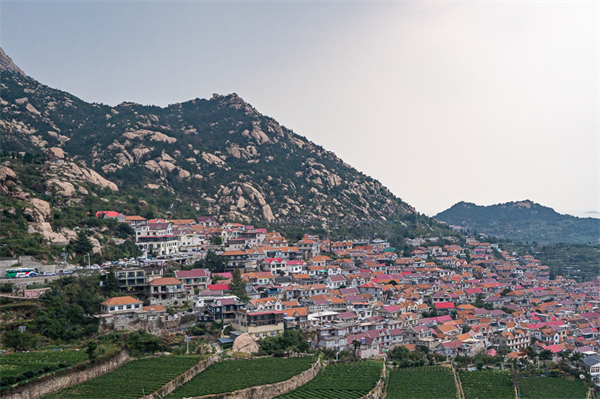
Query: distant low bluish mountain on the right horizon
[[433, 200, 600, 244]]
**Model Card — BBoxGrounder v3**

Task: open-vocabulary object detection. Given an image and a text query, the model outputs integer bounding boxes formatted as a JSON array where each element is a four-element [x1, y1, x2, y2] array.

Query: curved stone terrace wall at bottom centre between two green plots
[[191, 361, 321, 399]]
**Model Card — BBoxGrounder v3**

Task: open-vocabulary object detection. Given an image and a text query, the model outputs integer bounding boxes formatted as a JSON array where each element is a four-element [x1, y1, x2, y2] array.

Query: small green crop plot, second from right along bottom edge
[[460, 370, 515, 399]]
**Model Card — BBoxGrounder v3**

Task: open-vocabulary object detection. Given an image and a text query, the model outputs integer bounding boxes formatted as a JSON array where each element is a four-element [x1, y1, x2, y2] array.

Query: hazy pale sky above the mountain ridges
[[0, 0, 600, 219]]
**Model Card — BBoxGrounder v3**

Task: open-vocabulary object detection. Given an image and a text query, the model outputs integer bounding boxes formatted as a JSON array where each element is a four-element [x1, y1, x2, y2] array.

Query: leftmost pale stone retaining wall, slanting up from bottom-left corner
[[3, 351, 131, 399]]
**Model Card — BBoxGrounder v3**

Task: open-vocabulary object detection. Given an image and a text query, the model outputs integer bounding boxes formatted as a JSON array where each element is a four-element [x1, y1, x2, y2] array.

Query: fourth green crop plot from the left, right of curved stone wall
[[279, 362, 382, 399]]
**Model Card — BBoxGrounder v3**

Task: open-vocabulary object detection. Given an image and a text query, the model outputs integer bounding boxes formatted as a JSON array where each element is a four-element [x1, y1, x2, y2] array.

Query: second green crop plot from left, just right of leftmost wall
[[49, 356, 200, 399]]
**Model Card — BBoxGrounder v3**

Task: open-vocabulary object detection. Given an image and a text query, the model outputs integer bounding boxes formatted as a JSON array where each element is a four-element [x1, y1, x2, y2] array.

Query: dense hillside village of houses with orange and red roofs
[[92, 212, 600, 376]]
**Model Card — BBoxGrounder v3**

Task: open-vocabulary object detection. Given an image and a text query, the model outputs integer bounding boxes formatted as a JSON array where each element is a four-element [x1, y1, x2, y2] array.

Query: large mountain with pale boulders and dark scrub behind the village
[[0, 51, 440, 258]]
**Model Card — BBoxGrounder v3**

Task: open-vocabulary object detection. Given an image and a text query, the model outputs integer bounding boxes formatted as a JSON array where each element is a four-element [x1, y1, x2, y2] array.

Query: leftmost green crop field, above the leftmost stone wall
[[0, 350, 87, 387]]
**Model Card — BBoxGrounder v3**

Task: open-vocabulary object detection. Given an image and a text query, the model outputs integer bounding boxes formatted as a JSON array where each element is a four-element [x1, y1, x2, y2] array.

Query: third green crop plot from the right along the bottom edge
[[386, 367, 456, 399]]
